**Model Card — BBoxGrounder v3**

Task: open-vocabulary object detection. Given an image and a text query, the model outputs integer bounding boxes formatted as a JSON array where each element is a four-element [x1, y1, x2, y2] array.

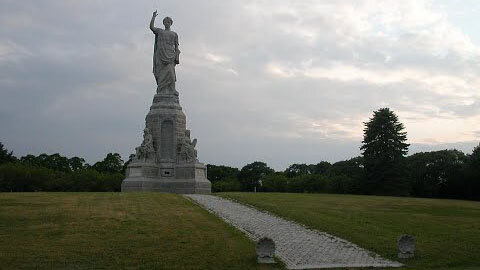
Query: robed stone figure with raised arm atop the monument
[[150, 10, 180, 95]]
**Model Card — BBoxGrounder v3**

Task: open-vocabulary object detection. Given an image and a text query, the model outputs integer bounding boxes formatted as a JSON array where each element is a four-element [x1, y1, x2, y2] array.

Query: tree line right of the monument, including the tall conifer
[[208, 108, 480, 200]]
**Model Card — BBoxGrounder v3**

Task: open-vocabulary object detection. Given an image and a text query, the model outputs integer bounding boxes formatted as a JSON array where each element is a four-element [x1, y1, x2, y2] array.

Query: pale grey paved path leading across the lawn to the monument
[[185, 194, 402, 269]]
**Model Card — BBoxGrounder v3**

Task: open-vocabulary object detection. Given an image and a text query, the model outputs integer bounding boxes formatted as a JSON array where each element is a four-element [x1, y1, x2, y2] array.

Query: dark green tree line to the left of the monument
[[0, 148, 126, 192]]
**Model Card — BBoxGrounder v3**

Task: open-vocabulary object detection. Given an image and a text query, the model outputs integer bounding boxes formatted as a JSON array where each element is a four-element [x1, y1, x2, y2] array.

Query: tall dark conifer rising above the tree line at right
[[360, 108, 409, 195]]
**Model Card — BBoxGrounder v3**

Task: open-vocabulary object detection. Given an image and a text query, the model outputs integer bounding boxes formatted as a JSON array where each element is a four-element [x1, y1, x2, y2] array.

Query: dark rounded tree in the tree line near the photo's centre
[[238, 161, 275, 191]]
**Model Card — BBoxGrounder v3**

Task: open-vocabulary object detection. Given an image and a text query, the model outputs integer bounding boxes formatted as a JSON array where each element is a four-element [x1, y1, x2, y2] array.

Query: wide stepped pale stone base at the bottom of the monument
[[122, 163, 212, 194]]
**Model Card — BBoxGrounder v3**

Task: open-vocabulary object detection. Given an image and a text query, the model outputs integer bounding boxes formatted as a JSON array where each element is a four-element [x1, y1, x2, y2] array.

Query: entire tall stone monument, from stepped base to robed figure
[[122, 11, 211, 193]]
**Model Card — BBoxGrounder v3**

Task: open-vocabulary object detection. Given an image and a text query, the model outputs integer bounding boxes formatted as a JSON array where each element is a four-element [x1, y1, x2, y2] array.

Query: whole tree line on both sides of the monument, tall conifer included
[[0, 108, 480, 200]]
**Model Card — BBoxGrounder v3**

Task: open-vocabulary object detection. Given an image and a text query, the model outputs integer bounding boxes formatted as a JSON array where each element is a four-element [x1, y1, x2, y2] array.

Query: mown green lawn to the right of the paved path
[[219, 193, 480, 269]]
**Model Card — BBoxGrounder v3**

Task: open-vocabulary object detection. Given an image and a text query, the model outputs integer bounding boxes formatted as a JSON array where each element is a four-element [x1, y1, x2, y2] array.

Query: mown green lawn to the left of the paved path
[[0, 193, 279, 269]]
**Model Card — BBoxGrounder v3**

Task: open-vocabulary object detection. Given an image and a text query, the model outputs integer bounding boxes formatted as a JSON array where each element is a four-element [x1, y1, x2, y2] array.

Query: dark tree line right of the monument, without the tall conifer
[[207, 145, 480, 200]]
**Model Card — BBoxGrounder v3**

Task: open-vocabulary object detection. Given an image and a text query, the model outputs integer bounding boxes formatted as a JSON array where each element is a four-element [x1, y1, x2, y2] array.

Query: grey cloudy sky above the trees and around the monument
[[0, 0, 480, 170]]
